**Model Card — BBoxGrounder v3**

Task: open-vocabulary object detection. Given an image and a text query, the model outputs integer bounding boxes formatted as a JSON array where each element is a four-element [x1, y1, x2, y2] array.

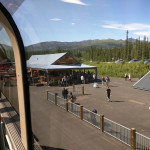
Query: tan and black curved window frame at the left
[[0, 2, 33, 150]]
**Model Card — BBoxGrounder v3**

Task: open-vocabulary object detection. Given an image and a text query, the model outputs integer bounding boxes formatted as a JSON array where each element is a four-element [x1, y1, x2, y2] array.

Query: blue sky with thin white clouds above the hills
[[3, 0, 150, 45]]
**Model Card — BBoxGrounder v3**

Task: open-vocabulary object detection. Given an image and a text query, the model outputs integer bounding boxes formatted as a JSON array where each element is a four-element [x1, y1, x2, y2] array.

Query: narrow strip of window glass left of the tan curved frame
[[0, 24, 19, 113]]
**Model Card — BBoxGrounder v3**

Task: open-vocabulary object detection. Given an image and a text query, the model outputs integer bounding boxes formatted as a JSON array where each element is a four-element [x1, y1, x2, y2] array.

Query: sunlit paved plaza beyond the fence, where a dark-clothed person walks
[[77, 78, 150, 137]]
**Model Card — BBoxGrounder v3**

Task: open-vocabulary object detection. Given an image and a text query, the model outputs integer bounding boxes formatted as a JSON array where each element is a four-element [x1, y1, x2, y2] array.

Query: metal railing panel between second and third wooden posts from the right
[[83, 108, 100, 129]]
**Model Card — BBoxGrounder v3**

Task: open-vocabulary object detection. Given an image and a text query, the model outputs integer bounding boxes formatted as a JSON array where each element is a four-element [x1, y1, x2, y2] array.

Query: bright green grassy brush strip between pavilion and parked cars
[[83, 62, 150, 78]]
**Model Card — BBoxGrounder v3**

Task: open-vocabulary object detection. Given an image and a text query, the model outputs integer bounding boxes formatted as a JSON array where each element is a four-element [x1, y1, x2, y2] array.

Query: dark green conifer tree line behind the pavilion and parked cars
[[26, 31, 150, 62]]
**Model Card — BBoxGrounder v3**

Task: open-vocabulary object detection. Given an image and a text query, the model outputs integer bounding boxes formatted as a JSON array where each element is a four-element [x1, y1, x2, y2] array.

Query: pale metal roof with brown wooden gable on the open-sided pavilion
[[27, 53, 97, 70]]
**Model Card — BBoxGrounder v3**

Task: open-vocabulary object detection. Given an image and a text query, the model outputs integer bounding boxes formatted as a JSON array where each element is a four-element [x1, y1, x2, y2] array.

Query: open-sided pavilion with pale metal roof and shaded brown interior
[[27, 53, 97, 85]]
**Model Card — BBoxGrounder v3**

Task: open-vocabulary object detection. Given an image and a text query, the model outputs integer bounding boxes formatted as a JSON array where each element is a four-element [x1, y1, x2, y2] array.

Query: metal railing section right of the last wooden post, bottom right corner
[[136, 132, 150, 150]]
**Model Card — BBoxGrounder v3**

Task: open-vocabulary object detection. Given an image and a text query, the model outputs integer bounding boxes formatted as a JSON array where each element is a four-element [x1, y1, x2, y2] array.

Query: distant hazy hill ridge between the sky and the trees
[[25, 39, 130, 51]]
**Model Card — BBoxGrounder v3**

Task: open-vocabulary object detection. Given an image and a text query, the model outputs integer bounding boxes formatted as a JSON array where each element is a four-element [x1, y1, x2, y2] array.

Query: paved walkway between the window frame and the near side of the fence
[[30, 85, 130, 150]]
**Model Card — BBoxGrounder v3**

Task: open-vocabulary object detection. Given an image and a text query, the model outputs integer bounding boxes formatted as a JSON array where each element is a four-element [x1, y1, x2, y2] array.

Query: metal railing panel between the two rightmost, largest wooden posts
[[104, 117, 131, 146]]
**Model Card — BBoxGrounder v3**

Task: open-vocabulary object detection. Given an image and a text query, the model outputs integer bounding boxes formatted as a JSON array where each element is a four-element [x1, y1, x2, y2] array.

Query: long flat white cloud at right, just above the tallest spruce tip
[[102, 23, 150, 31]]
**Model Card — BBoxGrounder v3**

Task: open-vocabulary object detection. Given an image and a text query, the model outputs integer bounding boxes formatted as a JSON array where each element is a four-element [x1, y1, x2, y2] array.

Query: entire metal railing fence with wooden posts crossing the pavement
[[47, 92, 150, 150]]
